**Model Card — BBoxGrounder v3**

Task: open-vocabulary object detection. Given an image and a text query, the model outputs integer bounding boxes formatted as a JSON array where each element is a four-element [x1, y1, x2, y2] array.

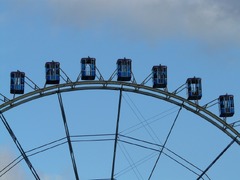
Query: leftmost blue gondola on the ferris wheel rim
[[10, 71, 25, 94]]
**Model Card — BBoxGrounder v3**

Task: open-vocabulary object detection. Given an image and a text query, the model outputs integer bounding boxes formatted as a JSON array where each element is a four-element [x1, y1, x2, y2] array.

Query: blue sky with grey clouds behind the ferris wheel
[[0, 0, 240, 180]]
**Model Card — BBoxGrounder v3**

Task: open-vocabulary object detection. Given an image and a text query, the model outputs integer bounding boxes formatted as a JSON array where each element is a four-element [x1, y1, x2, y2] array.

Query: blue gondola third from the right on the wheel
[[152, 65, 167, 88]]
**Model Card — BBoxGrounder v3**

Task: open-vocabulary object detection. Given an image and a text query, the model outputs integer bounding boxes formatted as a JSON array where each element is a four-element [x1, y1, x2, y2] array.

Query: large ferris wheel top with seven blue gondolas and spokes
[[0, 57, 240, 180]]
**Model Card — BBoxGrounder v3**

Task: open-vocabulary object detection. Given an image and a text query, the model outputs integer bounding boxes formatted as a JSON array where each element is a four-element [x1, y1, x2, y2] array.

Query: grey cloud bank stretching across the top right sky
[[45, 0, 240, 41]]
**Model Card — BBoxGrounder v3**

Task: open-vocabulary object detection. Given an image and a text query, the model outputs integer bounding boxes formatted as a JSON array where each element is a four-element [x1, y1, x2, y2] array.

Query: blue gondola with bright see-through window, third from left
[[81, 57, 96, 80]]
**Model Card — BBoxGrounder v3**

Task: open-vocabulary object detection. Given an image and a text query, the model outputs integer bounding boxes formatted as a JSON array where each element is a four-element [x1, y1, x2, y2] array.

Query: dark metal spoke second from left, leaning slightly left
[[58, 93, 79, 180]]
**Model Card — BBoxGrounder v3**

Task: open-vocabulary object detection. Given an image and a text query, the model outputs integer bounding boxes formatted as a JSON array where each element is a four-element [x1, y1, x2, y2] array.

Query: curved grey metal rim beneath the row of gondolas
[[0, 81, 240, 145]]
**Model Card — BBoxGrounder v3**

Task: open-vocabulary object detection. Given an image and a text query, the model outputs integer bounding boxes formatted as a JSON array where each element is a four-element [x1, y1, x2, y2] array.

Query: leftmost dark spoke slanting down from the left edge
[[0, 112, 40, 180]]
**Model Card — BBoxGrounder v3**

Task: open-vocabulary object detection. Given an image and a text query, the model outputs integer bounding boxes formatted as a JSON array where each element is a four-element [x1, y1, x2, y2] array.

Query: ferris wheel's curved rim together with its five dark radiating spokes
[[0, 59, 240, 180]]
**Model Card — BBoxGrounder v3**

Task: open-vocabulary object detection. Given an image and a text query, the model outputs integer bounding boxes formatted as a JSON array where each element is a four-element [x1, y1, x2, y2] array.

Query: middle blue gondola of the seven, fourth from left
[[117, 58, 132, 81]]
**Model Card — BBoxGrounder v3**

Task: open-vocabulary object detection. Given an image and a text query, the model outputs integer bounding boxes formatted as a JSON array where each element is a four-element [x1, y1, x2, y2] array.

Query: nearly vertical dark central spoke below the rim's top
[[111, 88, 122, 180]]
